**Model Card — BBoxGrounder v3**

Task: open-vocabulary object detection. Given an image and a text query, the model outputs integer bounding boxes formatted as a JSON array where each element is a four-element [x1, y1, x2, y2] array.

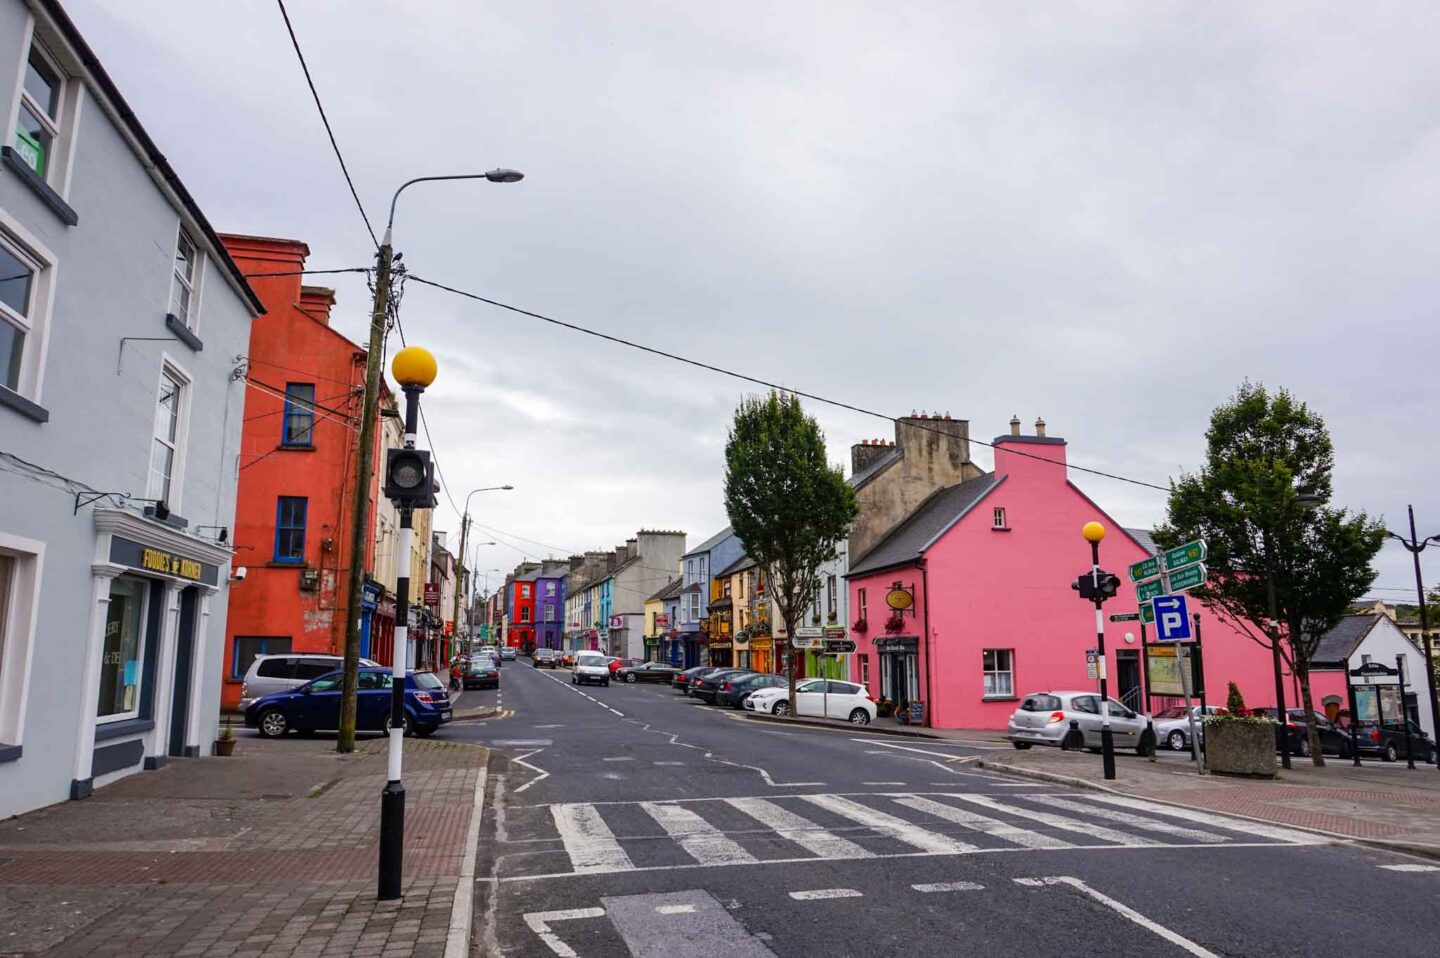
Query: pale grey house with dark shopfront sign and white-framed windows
[[0, 0, 262, 815]]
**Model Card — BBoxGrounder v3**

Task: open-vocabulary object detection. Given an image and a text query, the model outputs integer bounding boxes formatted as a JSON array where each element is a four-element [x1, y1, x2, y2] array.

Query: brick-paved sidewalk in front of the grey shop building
[[0, 735, 488, 958]]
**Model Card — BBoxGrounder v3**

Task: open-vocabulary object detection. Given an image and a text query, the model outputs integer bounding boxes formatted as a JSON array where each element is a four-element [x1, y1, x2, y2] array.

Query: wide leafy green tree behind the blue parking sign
[[1155, 382, 1385, 765]]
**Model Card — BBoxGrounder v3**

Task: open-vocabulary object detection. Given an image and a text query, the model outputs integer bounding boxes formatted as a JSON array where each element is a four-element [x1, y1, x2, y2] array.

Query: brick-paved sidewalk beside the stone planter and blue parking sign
[[979, 748, 1440, 857]]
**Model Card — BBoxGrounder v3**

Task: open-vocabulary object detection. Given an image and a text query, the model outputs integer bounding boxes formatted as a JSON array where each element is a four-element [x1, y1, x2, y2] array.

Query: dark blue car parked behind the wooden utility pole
[[245, 668, 451, 739]]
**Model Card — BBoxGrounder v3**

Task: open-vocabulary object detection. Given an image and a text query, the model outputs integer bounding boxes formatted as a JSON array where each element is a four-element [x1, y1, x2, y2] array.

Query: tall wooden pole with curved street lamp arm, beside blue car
[[336, 169, 524, 752]]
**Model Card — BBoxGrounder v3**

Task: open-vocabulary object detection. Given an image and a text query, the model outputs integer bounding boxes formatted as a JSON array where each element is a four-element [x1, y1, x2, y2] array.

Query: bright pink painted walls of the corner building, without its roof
[[850, 437, 1292, 728]]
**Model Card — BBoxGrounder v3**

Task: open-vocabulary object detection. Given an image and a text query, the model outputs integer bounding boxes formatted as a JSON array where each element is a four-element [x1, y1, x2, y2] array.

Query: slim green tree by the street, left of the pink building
[[724, 392, 858, 716]]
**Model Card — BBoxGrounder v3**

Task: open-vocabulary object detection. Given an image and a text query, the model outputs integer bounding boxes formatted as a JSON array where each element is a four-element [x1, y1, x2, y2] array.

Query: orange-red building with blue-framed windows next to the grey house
[[222, 235, 382, 709]]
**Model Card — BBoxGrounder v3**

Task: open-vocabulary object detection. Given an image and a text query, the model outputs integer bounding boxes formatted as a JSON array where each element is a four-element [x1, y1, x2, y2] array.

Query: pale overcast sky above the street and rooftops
[[68, 0, 1440, 599]]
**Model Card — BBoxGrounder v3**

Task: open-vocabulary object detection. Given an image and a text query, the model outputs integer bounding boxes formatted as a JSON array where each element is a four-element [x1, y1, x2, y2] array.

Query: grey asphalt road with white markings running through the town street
[[441, 658, 1440, 958]]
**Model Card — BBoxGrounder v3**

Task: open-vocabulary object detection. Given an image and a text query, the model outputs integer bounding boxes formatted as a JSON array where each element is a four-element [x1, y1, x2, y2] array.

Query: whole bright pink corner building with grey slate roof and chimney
[[847, 421, 1293, 728]]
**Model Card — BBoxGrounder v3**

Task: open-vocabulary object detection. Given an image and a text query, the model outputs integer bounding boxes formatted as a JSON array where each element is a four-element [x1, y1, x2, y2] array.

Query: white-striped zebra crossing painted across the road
[[497, 791, 1323, 882]]
